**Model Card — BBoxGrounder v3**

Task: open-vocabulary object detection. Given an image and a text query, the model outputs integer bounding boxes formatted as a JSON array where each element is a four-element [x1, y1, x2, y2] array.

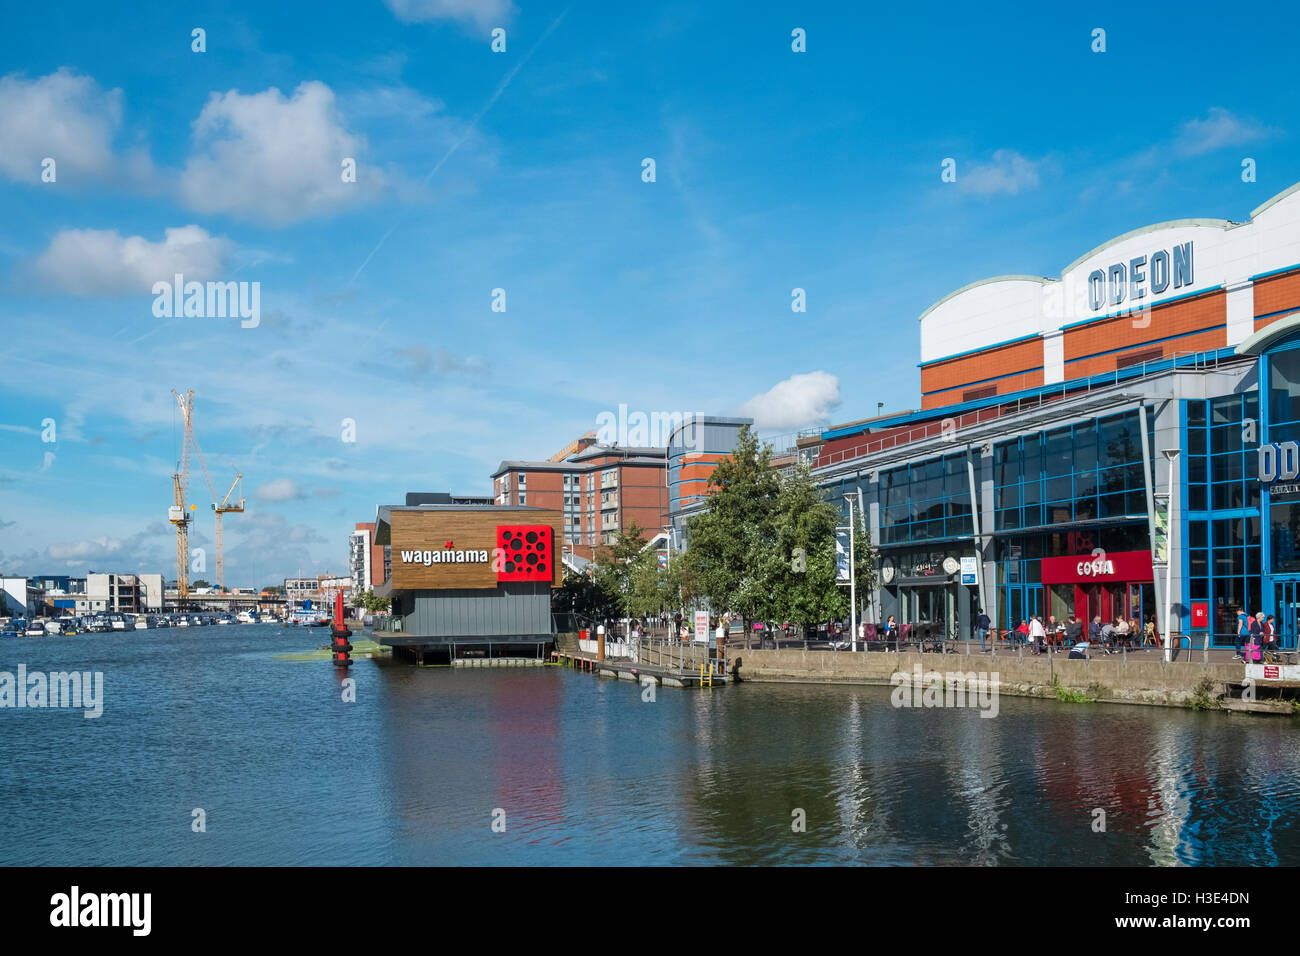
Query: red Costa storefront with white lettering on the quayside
[[1043, 550, 1156, 623]]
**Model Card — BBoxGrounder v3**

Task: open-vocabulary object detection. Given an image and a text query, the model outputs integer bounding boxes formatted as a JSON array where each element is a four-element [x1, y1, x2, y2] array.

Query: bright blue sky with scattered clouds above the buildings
[[0, 0, 1300, 585]]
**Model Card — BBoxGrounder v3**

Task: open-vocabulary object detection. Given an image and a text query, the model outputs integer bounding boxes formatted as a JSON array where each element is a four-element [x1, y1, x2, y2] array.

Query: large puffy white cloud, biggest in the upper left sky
[[179, 81, 384, 225]]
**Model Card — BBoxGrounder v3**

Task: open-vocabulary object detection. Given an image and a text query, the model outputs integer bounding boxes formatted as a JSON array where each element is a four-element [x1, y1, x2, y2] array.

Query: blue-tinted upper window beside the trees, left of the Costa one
[[880, 453, 974, 544]]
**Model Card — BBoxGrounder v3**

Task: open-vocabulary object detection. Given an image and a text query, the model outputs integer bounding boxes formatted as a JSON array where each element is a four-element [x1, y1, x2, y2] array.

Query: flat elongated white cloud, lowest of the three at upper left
[[33, 225, 234, 295]]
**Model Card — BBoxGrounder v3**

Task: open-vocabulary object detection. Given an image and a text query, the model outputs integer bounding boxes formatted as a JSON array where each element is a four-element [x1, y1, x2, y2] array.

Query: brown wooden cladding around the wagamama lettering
[[391, 507, 564, 591]]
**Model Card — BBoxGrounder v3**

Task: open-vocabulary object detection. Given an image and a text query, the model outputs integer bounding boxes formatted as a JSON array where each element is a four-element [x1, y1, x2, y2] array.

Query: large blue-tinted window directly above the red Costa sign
[[993, 411, 1147, 531]]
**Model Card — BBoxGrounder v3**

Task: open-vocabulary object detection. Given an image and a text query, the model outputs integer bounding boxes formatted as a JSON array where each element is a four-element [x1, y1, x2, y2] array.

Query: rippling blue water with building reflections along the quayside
[[0, 626, 1300, 865]]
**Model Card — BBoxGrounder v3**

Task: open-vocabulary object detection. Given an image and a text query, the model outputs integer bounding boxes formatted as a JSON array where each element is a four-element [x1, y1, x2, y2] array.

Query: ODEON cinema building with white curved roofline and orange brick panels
[[801, 185, 1300, 648]]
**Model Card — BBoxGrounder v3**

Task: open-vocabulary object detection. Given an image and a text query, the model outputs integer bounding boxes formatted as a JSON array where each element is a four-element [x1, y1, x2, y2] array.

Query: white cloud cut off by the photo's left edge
[[0, 68, 122, 183]]
